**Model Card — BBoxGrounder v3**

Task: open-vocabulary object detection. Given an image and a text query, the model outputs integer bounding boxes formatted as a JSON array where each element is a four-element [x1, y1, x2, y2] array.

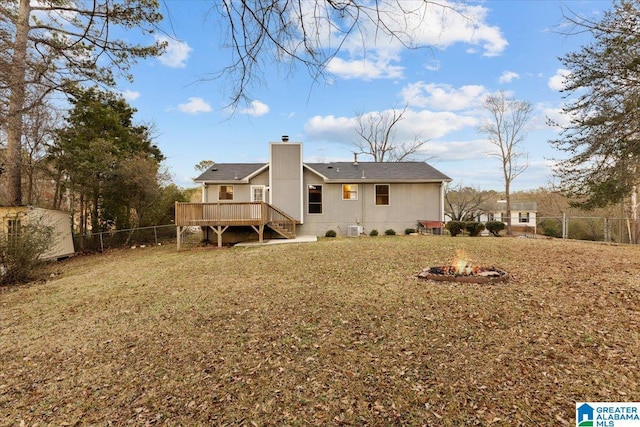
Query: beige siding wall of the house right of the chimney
[[298, 170, 443, 236]]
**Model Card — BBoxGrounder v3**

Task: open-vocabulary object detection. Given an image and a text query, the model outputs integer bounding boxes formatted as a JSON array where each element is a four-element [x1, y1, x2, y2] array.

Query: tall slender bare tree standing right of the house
[[480, 91, 533, 236]]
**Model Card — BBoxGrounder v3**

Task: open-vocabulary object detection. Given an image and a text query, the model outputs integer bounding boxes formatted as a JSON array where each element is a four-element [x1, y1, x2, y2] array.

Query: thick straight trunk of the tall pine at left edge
[[7, 0, 31, 206]]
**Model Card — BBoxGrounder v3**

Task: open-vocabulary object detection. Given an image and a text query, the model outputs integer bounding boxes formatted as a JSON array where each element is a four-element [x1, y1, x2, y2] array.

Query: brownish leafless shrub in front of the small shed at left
[[0, 218, 54, 284]]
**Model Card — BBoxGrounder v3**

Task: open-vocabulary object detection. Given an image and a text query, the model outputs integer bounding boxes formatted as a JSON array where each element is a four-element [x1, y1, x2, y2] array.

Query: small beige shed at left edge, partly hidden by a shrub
[[0, 206, 75, 260]]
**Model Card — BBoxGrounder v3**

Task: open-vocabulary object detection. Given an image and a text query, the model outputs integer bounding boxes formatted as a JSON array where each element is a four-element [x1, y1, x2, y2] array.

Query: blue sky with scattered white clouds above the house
[[118, 0, 612, 190]]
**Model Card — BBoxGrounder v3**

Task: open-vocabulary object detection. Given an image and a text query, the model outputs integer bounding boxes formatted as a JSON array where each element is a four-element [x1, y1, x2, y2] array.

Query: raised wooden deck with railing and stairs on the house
[[175, 202, 296, 249]]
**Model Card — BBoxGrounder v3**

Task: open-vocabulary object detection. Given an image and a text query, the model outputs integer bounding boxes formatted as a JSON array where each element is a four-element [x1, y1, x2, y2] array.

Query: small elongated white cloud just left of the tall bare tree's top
[[401, 82, 486, 111]]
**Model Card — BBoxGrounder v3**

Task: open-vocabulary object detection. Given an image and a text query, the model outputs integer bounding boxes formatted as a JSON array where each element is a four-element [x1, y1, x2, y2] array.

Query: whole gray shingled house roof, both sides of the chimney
[[195, 162, 451, 182]]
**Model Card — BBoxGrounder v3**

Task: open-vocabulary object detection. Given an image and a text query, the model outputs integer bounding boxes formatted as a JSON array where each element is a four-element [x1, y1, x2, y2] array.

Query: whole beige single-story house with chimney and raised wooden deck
[[176, 137, 451, 245]]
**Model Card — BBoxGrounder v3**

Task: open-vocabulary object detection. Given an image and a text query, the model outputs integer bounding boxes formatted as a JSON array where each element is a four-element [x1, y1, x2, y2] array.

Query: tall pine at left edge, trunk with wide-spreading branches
[[0, 0, 163, 205]]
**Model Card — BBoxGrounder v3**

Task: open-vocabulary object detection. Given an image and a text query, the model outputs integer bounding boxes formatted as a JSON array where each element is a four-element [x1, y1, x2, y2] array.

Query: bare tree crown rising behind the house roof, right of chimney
[[353, 106, 428, 162]]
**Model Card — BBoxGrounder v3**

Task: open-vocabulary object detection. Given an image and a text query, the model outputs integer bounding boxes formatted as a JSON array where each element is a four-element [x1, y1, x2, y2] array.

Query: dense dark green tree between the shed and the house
[[50, 88, 164, 232]]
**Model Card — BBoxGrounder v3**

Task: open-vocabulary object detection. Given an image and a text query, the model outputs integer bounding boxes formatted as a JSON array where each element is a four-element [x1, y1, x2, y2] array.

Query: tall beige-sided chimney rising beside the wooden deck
[[269, 143, 303, 221]]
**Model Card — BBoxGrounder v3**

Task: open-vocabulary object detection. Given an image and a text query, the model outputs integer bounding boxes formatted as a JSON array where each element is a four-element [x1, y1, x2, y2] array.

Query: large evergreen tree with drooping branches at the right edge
[[551, 0, 640, 209]]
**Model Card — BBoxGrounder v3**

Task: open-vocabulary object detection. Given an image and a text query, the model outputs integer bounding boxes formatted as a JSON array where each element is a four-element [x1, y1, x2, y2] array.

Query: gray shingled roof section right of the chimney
[[305, 162, 451, 182]]
